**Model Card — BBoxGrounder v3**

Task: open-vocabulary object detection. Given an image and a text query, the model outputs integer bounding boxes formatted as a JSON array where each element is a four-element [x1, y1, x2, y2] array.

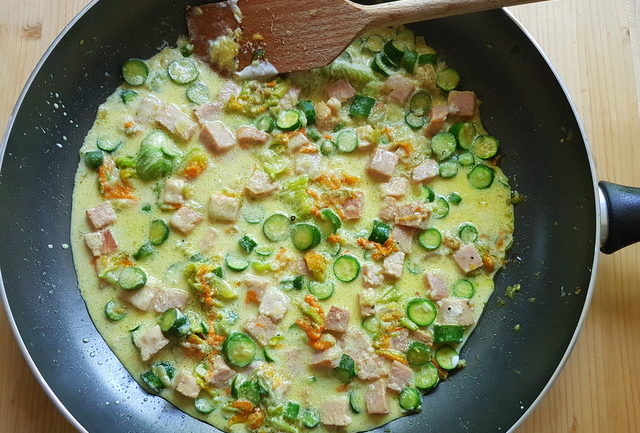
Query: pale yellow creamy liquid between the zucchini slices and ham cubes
[[71, 29, 513, 432]]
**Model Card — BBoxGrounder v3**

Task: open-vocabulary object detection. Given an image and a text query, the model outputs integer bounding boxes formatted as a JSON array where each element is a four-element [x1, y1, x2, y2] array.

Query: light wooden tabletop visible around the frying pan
[[0, 0, 640, 433]]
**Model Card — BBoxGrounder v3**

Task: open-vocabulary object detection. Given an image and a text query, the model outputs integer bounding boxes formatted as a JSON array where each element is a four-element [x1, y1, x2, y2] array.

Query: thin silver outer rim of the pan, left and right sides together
[[0, 0, 601, 433]]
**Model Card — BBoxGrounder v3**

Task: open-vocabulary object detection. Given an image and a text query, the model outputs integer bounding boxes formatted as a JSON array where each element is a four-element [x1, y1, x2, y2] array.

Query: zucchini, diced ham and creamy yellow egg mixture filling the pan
[[72, 27, 514, 433]]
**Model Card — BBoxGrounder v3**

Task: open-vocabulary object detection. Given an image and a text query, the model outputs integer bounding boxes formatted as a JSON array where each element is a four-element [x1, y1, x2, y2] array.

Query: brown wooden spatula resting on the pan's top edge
[[187, 0, 541, 73]]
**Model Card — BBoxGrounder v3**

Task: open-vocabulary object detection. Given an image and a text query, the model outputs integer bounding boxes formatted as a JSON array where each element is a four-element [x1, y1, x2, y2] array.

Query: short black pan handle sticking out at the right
[[598, 182, 640, 254]]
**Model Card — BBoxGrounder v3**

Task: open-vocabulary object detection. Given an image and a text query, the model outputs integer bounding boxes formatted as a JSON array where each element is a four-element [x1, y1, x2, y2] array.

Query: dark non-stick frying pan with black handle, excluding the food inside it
[[0, 0, 640, 433]]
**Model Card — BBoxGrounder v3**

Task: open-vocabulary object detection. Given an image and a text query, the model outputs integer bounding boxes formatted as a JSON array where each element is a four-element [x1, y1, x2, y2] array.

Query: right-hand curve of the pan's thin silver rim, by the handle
[[503, 9, 602, 433]]
